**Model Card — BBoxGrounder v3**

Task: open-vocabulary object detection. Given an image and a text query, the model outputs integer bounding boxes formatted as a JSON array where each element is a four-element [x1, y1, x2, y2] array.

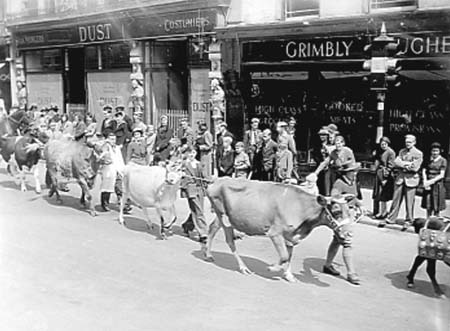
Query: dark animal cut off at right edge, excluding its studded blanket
[[406, 217, 450, 296]]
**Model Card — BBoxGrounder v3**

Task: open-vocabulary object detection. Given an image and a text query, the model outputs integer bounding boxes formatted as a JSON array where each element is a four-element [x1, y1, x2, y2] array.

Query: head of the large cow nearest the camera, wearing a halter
[[317, 194, 355, 230]]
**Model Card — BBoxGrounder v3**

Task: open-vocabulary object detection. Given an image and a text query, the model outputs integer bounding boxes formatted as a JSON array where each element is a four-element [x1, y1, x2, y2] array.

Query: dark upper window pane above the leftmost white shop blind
[[25, 49, 63, 72]]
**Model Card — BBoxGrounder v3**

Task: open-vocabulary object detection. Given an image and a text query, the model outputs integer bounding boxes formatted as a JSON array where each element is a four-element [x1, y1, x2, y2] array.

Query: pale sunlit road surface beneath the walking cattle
[[0, 162, 450, 331]]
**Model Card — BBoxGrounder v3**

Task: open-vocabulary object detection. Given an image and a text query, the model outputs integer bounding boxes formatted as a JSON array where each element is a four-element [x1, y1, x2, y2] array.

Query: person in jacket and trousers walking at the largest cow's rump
[[181, 146, 208, 245]]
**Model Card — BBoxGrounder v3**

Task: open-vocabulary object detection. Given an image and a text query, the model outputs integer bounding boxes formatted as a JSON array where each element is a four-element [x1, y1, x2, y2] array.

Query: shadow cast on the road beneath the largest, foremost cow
[[191, 251, 330, 287]]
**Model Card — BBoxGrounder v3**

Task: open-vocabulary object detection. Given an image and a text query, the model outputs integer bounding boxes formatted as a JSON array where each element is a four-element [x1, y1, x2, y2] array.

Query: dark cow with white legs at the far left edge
[[0, 128, 48, 194]]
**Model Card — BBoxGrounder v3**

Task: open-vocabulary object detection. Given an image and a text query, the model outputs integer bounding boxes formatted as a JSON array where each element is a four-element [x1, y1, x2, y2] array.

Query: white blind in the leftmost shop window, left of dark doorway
[[27, 74, 64, 109]]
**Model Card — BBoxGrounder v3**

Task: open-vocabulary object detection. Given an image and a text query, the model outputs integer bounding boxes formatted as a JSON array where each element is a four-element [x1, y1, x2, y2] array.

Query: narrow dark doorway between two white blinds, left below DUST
[[66, 48, 86, 107]]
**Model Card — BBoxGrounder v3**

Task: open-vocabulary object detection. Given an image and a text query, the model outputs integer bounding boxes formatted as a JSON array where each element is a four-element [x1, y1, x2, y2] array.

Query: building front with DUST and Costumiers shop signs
[[7, 0, 228, 130]]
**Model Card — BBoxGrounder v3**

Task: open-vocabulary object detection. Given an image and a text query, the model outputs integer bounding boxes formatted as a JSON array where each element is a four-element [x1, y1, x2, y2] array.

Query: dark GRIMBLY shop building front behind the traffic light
[[218, 0, 450, 166]]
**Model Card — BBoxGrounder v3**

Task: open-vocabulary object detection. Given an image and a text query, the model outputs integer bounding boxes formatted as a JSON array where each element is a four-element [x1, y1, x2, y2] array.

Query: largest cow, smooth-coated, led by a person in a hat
[[203, 177, 354, 282]]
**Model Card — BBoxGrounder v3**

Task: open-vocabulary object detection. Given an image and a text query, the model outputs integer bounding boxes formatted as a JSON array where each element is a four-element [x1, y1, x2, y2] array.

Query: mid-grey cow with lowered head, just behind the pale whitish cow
[[44, 139, 99, 216]]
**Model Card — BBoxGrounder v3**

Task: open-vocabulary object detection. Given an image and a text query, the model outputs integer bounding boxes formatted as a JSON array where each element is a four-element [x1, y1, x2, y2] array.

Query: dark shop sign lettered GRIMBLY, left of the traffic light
[[243, 38, 366, 61]]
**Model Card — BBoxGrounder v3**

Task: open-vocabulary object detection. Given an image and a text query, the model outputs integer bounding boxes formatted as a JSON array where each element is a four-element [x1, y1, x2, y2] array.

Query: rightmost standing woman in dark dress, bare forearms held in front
[[422, 142, 447, 218]]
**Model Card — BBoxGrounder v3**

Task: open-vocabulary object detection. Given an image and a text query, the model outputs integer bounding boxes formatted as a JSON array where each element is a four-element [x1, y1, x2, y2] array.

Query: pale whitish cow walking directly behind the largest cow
[[119, 162, 185, 239]]
